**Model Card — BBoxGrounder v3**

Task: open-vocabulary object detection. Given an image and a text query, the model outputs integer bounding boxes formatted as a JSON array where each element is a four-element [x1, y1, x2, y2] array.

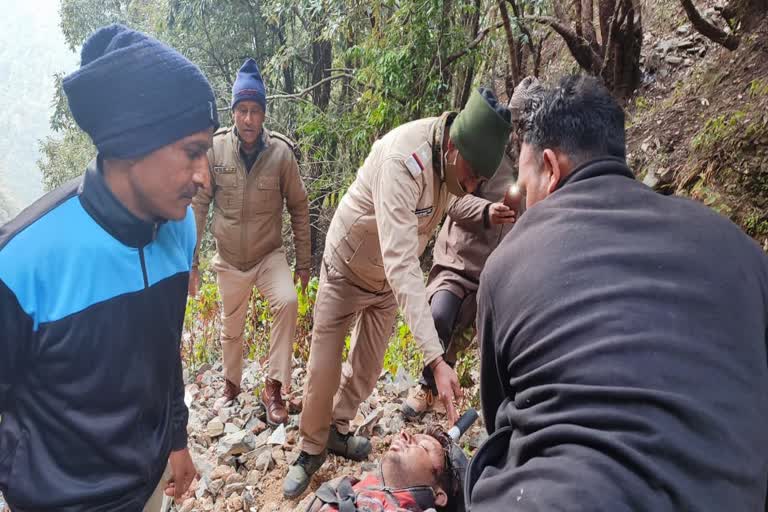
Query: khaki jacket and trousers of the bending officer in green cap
[[300, 113, 455, 454]]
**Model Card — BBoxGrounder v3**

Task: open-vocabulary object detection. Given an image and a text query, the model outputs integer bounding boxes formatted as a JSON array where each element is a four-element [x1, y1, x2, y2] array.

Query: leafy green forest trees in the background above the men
[[39, 0, 543, 198]]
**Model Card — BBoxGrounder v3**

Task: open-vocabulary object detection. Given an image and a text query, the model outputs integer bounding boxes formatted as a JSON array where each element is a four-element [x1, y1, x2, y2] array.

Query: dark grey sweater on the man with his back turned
[[466, 159, 768, 512]]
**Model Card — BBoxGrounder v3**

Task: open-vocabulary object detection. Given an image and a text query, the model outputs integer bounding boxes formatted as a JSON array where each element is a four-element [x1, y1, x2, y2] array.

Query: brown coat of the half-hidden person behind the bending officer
[[427, 153, 515, 299]]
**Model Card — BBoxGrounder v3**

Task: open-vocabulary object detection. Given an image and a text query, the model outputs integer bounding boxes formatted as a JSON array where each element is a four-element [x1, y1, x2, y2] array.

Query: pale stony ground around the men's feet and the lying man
[[174, 362, 485, 512]]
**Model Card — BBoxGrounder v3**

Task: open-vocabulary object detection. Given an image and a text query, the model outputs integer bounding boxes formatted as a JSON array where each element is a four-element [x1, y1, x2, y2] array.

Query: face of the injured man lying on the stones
[[381, 431, 453, 507]]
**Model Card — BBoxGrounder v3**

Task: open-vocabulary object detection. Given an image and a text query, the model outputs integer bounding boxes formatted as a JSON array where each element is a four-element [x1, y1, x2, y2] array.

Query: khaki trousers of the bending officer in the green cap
[[300, 261, 397, 455]]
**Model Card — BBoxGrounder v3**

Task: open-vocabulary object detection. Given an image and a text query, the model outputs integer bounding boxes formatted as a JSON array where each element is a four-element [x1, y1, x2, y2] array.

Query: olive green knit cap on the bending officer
[[450, 88, 512, 179]]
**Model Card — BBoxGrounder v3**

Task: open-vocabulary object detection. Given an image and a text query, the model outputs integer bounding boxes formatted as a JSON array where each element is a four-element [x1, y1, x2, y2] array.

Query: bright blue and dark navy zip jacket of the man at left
[[0, 158, 195, 512]]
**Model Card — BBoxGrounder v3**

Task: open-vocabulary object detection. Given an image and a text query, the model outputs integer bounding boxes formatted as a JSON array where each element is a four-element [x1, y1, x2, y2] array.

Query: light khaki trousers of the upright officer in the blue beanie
[[213, 248, 298, 391]]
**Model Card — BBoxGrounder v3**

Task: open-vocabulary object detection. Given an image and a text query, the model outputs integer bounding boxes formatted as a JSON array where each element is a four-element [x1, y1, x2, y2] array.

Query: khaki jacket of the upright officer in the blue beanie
[[192, 128, 311, 271]]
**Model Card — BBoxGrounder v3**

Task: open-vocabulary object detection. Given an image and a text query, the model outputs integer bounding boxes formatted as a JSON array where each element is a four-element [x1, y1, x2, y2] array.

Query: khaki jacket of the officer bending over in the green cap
[[325, 113, 454, 363]]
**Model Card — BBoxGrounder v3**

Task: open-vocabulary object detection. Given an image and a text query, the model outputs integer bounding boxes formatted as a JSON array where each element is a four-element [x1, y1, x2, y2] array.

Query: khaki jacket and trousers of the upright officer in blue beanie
[[192, 128, 311, 388]]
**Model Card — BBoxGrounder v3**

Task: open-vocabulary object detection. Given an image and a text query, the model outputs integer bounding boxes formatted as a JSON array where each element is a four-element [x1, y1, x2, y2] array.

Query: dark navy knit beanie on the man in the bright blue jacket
[[63, 24, 219, 159]]
